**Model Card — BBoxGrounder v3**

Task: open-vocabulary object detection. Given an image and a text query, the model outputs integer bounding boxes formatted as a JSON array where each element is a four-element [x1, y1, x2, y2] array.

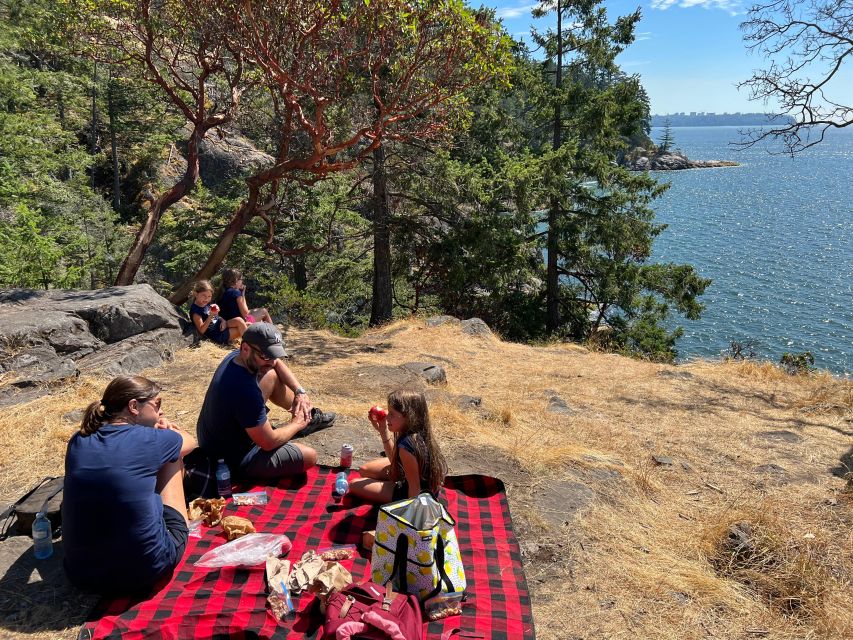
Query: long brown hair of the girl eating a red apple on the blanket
[[388, 389, 447, 494]]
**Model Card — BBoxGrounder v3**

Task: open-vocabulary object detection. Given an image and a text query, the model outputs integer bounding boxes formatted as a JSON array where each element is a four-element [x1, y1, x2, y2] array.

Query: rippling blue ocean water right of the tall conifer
[[652, 127, 853, 376]]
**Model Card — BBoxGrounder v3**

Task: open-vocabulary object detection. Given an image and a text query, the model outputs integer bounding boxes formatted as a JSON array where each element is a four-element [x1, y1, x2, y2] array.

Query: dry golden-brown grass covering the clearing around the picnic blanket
[[0, 321, 853, 640]]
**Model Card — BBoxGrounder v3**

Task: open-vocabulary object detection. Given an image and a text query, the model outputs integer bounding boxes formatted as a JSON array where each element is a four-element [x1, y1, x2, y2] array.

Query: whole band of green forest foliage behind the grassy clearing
[[0, 0, 704, 366]]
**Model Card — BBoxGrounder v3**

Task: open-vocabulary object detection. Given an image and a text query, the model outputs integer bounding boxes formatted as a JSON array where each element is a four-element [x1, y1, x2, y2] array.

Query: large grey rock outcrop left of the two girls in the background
[[0, 284, 193, 405]]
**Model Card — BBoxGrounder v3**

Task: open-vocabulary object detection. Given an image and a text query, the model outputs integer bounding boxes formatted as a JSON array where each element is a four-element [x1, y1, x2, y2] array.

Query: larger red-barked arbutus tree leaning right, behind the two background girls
[[170, 0, 510, 304]]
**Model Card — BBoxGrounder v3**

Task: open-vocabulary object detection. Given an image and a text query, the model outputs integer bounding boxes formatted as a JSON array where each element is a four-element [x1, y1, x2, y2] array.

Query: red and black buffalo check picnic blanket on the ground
[[79, 467, 535, 640]]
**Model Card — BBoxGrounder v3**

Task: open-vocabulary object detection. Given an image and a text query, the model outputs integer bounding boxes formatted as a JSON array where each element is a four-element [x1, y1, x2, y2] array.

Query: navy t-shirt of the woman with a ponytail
[[62, 424, 183, 592]]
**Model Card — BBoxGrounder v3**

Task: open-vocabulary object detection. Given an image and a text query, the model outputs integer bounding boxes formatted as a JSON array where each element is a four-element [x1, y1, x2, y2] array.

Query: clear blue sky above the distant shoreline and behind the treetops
[[482, 0, 808, 114]]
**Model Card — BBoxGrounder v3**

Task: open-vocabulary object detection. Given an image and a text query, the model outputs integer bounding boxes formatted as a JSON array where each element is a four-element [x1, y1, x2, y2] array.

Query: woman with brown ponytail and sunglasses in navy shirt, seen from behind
[[62, 376, 196, 593]]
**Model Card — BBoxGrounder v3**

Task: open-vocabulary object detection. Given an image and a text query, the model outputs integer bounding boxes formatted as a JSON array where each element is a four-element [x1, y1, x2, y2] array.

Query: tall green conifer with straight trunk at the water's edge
[[520, 0, 709, 360]]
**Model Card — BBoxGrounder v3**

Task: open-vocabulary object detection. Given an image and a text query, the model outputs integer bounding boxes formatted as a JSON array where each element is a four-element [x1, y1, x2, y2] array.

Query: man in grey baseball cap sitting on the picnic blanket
[[196, 322, 335, 480]]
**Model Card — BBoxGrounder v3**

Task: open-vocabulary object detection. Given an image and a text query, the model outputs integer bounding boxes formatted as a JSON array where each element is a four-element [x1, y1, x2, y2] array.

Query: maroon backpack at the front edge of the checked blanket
[[323, 582, 423, 640]]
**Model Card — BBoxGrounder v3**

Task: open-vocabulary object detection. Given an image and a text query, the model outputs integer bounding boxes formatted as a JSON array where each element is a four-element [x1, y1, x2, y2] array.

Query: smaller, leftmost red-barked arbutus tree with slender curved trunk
[[59, 0, 251, 285]]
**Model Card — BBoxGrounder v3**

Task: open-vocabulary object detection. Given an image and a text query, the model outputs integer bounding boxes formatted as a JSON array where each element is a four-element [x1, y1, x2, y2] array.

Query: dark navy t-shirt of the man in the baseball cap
[[196, 351, 267, 469]]
